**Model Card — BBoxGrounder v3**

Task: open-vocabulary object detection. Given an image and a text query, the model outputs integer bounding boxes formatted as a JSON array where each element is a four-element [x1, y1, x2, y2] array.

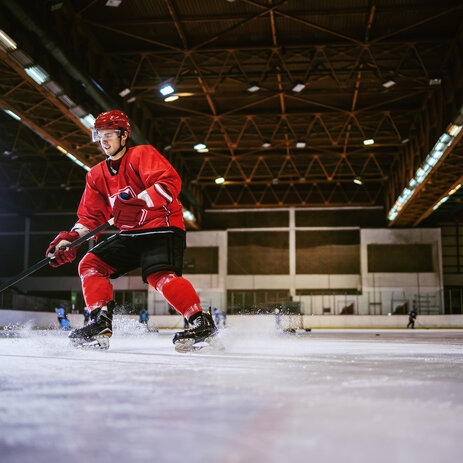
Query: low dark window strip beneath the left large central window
[[227, 289, 290, 314]]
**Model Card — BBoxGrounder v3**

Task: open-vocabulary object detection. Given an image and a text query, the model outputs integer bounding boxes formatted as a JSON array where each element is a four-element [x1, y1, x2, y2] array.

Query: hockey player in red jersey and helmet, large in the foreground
[[46, 110, 217, 352]]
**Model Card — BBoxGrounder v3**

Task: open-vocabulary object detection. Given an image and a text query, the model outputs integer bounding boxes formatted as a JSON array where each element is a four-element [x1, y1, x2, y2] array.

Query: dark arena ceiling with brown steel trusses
[[0, 0, 463, 226]]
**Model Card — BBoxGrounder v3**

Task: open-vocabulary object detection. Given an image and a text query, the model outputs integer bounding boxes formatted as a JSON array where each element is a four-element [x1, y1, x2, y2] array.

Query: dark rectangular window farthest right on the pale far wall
[[367, 244, 434, 273]]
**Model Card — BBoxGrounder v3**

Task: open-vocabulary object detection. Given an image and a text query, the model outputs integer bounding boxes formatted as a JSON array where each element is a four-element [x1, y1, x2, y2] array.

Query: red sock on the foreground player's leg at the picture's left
[[79, 252, 116, 311]]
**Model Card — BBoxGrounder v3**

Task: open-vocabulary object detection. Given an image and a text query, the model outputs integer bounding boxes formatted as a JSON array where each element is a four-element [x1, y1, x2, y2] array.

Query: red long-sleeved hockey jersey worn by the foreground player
[[77, 145, 185, 231]]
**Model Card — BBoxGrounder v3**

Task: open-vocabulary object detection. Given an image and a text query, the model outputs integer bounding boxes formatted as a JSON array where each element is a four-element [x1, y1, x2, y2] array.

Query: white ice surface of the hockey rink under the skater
[[0, 329, 463, 463]]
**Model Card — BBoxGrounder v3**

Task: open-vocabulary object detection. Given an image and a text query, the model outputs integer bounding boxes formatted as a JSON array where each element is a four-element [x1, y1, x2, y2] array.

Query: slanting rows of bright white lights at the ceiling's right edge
[[387, 108, 463, 221]]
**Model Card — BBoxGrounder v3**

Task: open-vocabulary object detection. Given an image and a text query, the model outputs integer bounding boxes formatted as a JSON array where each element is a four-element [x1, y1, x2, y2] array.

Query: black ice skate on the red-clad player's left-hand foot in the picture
[[69, 301, 115, 350]]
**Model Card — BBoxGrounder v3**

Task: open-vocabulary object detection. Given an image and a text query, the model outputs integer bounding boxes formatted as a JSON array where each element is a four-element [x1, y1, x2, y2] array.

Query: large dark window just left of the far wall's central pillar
[[228, 231, 289, 275]]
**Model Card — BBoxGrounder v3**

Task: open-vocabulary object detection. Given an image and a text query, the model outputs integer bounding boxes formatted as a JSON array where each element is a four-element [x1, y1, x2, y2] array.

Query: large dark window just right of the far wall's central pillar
[[296, 230, 360, 275]]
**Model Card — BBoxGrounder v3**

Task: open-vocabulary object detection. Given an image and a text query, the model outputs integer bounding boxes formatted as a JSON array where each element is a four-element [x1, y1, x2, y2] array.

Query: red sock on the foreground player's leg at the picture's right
[[147, 271, 202, 320]]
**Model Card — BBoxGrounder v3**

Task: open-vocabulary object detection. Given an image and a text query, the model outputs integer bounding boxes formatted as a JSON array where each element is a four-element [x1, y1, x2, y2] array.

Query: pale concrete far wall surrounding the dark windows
[[9, 212, 443, 315]]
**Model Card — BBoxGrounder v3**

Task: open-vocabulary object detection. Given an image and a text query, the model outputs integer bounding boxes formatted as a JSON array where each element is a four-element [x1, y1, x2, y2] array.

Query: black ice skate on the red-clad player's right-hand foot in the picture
[[172, 312, 224, 352]]
